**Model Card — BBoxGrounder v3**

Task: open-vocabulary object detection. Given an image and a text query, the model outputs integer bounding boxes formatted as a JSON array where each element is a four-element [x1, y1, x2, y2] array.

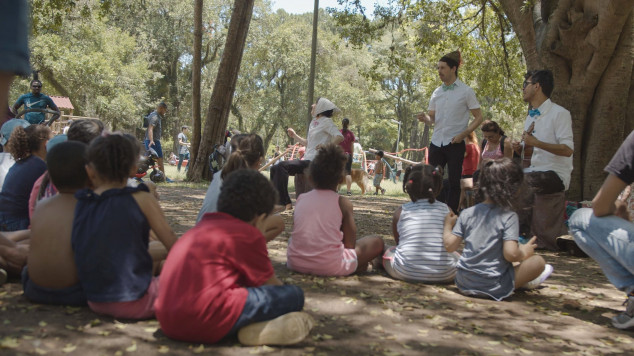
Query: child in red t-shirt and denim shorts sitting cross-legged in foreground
[[156, 169, 313, 345]]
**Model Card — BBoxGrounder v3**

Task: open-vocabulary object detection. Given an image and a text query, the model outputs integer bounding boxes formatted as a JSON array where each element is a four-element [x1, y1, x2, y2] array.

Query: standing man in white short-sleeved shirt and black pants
[[417, 51, 482, 213]]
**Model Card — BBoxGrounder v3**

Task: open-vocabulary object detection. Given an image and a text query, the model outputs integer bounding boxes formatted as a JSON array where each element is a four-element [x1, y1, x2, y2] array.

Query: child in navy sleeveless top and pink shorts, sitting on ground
[[71, 134, 176, 319]]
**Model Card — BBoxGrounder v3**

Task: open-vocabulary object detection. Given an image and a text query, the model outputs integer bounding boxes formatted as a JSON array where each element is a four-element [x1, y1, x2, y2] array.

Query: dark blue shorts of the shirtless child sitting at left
[[22, 267, 87, 306]]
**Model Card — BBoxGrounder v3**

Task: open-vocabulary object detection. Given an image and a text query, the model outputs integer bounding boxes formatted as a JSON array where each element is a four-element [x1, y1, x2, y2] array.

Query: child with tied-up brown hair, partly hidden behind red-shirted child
[[196, 134, 284, 242]]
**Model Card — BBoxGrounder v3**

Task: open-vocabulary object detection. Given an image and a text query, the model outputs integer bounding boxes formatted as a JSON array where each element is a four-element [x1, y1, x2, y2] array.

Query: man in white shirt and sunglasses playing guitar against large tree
[[513, 70, 574, 249]]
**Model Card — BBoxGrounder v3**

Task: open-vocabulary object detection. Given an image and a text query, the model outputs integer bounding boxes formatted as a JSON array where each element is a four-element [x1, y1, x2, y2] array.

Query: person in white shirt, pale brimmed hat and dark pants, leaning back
[[271, 98, 343, 210]]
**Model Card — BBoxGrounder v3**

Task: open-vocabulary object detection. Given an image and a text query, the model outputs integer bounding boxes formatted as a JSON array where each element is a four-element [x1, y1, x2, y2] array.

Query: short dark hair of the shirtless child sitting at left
[[47, 141, 88, 192]]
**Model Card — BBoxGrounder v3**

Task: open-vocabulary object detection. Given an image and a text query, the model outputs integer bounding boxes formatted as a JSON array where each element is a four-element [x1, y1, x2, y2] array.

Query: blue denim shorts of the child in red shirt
[[226, 285, 304, 336]]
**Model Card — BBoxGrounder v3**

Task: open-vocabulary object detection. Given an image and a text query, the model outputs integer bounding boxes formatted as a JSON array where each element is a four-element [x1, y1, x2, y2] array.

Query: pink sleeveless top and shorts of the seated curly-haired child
[[286, 189, 357, 276]]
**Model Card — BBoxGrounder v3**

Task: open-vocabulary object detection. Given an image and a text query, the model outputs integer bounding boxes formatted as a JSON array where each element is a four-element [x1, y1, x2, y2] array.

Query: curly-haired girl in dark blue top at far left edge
[[0, 125, 51, 231]]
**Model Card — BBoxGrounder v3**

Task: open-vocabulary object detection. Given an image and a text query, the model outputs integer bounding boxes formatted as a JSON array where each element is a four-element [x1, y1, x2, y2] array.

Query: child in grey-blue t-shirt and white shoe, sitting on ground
[[443, 158, 553, 301]]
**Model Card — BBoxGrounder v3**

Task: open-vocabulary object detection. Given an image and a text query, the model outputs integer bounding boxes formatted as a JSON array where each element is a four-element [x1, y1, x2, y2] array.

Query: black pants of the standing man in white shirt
[[429, 141, 467, 213]]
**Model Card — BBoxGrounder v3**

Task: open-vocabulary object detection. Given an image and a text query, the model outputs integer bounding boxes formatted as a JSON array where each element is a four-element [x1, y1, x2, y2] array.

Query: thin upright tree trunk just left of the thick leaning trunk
[[187, 0, 203, 180]]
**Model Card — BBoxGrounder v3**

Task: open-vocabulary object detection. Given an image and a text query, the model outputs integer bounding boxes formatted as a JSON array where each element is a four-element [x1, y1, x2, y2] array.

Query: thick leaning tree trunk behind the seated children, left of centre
[[190, 0, 254, 181]]
